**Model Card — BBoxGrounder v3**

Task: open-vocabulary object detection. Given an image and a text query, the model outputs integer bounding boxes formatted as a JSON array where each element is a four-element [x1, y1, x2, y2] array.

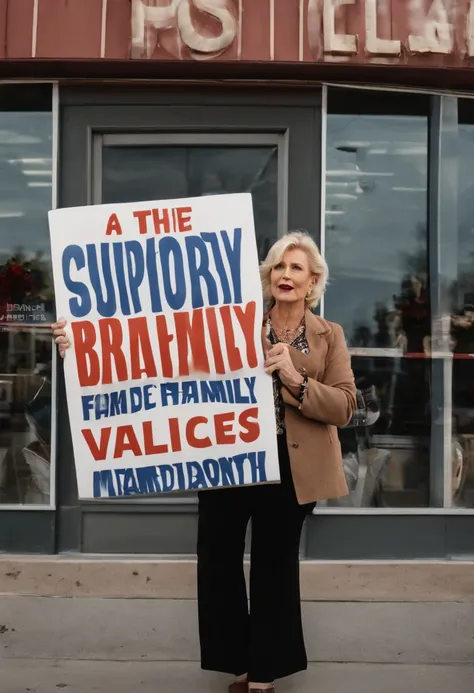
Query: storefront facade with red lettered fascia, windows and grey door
[[0, 0, 474, 560]]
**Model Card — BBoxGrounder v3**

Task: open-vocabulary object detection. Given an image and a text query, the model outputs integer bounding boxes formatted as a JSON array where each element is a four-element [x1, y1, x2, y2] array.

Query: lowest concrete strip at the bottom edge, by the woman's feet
[[0, 659, 474, 693]]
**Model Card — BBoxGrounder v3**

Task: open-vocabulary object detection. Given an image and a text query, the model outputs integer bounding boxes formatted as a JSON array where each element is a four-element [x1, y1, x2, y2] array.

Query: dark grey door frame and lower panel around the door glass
[[57, 83, 322, 555]]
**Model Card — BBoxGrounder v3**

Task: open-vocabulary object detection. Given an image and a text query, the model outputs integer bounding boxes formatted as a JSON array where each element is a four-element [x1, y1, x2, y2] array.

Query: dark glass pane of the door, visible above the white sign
[[102, 146, 278, 259]]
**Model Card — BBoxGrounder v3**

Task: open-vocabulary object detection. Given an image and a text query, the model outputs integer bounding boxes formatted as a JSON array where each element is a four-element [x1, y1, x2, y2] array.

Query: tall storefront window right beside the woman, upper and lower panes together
[[324, 89, 432, 508]]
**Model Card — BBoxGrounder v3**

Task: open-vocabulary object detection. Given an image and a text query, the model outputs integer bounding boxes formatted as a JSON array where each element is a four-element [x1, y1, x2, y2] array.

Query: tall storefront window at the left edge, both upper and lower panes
[[0, 85, 54, 509]]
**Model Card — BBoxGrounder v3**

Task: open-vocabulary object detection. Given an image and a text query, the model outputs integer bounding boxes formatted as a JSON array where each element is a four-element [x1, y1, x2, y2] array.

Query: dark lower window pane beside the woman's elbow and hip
[[320, 357, 431, 507]]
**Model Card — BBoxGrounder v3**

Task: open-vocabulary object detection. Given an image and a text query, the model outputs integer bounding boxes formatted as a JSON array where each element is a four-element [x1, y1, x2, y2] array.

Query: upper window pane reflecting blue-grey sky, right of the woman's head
[[325, 89, 430, 354]]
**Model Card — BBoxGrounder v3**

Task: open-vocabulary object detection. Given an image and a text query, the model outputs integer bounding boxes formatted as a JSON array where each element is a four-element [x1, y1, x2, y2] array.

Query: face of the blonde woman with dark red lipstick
[[270, 248, 316, 303]]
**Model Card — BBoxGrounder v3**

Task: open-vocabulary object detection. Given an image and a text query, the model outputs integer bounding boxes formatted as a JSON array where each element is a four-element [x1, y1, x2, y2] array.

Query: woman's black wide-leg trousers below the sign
[[197, 435, 314, 683]]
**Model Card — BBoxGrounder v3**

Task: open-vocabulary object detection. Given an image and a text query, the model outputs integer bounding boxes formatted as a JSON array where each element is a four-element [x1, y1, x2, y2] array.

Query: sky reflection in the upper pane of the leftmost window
[[0, 112, 54, 324]]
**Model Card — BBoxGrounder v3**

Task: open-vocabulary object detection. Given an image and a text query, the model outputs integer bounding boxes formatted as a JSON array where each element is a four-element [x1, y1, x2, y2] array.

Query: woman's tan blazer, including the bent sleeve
[[262, 310, 356, 504]]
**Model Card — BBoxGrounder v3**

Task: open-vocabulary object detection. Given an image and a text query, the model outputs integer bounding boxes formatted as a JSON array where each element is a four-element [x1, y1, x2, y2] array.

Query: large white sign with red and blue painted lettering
[[49, 194, 279, 498]]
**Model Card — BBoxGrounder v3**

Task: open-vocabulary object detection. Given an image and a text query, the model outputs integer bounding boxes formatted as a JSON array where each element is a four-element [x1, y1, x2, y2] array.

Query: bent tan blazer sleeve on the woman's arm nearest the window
[[282, 325, 356, 426]]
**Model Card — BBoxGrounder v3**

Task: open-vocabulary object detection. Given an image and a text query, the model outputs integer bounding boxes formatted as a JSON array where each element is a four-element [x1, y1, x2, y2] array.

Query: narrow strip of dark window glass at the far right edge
[[451, 99, 474, 508]]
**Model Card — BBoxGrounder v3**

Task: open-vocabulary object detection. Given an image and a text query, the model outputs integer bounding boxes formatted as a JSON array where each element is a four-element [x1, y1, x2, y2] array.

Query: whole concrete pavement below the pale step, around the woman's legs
[[0, 597, 474, 693]]
